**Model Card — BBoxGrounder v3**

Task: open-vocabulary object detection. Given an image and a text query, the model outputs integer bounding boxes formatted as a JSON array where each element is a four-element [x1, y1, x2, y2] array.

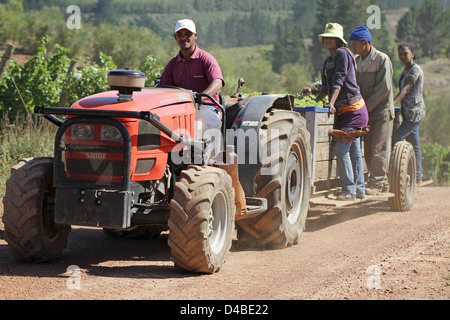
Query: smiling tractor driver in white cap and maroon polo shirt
[[159, 19, 225, 158]]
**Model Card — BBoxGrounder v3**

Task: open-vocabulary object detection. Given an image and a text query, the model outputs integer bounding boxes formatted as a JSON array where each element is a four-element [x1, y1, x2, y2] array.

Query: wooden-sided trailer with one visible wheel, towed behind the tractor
[[294, 106, 426, 211]]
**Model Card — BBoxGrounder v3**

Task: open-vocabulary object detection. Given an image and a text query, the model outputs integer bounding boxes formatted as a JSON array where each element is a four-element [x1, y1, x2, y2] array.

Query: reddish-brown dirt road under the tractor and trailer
[[0, 187, 450, 300]]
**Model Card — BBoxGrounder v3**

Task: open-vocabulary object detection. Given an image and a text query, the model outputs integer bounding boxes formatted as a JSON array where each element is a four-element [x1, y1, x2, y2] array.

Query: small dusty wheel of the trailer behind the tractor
[[389, 141, 416, 212]]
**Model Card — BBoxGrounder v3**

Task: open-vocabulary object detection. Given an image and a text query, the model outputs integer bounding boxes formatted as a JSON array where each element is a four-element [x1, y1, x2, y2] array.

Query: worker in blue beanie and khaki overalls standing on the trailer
[[350, 26, 395, 195]]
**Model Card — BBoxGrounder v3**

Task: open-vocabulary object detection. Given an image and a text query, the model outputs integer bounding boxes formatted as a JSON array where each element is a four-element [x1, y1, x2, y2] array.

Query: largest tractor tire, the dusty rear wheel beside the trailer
[[236, 110, 311, 249]]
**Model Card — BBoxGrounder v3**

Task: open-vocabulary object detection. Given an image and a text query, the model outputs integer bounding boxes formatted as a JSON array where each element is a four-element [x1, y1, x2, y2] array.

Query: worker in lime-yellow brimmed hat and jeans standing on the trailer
[[318, 23, 368, 200]]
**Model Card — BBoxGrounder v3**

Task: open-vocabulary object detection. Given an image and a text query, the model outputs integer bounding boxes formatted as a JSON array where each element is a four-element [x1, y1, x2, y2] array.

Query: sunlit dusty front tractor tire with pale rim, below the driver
[[168, 166, 236, 273]]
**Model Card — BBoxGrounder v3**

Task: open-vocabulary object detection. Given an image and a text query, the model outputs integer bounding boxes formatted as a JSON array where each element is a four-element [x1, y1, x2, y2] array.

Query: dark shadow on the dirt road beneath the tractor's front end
[[0, 228, 201, 278]]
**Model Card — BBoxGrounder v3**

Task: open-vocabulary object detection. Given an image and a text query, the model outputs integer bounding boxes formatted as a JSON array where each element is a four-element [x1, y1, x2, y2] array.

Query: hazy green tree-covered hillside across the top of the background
[[0, 0, 450, 73]]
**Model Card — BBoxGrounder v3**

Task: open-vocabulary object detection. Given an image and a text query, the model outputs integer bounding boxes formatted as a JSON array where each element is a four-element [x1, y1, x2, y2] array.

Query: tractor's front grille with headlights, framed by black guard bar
[[55, 118, 131, 190]]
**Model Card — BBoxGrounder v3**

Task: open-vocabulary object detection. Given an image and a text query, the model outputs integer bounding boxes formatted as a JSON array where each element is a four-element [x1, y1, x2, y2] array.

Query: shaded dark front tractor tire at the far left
[[3, 158, 70, 262]]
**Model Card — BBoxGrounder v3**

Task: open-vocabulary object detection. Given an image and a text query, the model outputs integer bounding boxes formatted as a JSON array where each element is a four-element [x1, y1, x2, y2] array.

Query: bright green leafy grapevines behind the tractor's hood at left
[[0, 36, 162, 120]]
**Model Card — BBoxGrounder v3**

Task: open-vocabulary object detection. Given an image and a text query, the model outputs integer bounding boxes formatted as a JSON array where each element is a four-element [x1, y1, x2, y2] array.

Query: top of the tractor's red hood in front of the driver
[[71, 88, 194, 112]]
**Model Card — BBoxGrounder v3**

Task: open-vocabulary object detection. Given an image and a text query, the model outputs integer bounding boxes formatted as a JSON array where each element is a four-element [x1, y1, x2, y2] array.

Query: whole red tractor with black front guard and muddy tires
[[3, 70, 311, 273]]
